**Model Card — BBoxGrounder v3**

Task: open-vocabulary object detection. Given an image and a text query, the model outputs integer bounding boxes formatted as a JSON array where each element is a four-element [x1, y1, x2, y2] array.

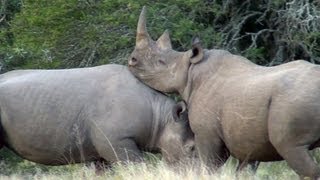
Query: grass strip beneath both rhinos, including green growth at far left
[[0, 149, 304, 180]]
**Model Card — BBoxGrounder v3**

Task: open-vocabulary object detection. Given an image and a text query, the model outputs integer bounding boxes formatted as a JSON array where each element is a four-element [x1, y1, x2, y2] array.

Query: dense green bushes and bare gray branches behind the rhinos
[[0, 0, 320, 178]]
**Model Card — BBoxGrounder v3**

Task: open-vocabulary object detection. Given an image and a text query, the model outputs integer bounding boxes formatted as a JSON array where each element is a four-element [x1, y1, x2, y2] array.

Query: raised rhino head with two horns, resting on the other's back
[[128, 7, 203, 93]]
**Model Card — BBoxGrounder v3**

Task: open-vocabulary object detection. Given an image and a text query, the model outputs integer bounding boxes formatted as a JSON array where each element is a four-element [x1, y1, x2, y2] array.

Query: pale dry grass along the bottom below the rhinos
[[0, 159, 298, 180]]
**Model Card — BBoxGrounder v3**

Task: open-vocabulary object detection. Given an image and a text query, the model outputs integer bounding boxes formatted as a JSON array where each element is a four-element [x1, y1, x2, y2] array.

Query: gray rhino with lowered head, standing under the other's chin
[[0, 65, 194, 165]]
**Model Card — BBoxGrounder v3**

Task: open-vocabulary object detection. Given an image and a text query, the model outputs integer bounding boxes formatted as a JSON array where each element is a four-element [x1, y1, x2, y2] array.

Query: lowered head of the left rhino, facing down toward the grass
[[157, 101, 195, 164]]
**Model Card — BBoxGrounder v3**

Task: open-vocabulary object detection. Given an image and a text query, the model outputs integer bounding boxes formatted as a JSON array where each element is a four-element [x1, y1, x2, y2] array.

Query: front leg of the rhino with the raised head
[[195, 135, 230, 169]]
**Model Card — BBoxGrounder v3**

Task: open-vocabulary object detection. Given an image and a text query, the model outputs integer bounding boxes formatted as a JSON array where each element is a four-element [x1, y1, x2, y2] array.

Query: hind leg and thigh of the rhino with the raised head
[[268, 98, 320, 179]]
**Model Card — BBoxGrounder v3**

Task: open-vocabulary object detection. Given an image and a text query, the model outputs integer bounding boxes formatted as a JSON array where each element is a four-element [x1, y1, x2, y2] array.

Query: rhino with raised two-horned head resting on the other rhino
[[128, 8, 320, 178]]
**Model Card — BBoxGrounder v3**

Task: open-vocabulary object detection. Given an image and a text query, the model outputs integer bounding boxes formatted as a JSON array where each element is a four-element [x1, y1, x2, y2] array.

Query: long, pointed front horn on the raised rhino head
[[136, 6, 150, 48]]
